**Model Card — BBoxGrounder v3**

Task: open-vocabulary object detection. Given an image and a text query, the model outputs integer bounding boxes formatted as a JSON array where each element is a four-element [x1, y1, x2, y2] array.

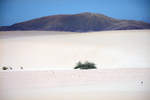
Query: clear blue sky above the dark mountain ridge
[[0, 0, 150, 26]]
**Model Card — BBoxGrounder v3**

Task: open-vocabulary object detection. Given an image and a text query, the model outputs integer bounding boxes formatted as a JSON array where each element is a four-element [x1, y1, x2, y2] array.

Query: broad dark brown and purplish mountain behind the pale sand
[[0, 12, 150, 32]]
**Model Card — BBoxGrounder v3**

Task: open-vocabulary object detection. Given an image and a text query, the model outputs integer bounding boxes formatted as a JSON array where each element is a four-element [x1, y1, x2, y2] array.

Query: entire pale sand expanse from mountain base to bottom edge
[[0, 30, 150, 100]]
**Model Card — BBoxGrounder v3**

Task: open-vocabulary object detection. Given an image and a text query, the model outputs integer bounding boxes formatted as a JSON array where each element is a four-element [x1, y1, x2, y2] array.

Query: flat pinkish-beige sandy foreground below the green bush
[[0, 68, 150, 100]]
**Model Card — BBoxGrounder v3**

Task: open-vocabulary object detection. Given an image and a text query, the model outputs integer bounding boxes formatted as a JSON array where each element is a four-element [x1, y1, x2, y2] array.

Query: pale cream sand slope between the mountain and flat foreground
[[0, 30, 150, 69]]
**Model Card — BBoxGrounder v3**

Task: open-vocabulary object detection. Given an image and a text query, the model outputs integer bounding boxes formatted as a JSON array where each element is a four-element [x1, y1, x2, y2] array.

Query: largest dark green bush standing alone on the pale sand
[[74, 61, 96, 69]]
